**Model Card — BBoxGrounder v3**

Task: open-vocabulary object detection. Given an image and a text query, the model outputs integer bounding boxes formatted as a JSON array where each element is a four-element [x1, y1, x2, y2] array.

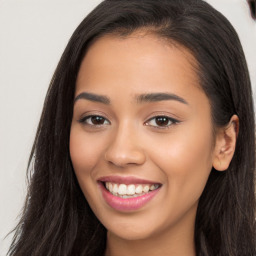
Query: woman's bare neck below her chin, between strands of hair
[[105, 207, 196, 256]]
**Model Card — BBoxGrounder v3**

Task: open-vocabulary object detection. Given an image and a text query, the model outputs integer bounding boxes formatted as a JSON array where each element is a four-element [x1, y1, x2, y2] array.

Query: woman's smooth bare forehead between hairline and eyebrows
[[76, 33, 204, 103]]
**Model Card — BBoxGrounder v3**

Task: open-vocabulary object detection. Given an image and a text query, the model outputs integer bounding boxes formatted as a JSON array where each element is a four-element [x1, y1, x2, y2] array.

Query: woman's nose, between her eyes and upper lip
[[105, 122, 146, 167]]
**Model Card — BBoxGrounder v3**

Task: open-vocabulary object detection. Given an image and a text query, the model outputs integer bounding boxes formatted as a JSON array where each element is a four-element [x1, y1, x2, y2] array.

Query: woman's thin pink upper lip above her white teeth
[[98, 175, 160, 185]]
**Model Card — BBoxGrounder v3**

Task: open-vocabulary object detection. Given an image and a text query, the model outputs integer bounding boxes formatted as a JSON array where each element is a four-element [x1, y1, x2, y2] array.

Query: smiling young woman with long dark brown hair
[[9, 0, 256, 256]]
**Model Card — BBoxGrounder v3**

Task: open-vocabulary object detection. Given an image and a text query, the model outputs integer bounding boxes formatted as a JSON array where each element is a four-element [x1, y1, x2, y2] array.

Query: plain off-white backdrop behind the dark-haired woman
[[0, 0, 256, 256]]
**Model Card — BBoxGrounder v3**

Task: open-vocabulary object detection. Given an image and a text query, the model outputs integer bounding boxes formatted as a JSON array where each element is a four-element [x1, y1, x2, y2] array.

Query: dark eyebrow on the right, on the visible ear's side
[[136, 92, 188, 105]]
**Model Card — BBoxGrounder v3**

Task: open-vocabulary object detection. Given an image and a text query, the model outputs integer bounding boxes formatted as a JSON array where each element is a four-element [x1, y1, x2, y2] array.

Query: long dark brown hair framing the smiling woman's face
[[8, 0, 256, 256]]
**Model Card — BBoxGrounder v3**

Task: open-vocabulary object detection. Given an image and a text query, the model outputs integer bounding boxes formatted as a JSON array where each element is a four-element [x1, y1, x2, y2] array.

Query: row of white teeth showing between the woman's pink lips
[[105, 182, 159, 198]]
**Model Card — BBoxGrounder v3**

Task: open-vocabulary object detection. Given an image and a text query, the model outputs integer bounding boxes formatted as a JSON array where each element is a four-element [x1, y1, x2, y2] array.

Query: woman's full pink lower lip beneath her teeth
[[99, 182, 160, 212]]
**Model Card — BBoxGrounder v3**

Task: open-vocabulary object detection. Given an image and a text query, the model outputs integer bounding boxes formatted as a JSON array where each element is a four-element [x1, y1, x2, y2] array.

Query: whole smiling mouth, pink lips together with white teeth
[[98, 176, 162, 212]]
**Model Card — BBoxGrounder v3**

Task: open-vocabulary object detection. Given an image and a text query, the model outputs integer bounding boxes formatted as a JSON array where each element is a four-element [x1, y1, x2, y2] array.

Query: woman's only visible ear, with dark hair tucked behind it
[[212, 115, 239, 171]]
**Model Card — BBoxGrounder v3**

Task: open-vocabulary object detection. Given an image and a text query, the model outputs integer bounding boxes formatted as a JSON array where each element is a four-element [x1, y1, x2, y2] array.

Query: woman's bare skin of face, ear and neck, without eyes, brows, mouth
[[70, 32, 238, 256]]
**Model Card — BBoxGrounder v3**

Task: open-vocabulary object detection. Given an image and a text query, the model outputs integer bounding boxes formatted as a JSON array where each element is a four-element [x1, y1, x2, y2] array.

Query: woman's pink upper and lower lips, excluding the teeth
[[99, 176, 160, 212]]
